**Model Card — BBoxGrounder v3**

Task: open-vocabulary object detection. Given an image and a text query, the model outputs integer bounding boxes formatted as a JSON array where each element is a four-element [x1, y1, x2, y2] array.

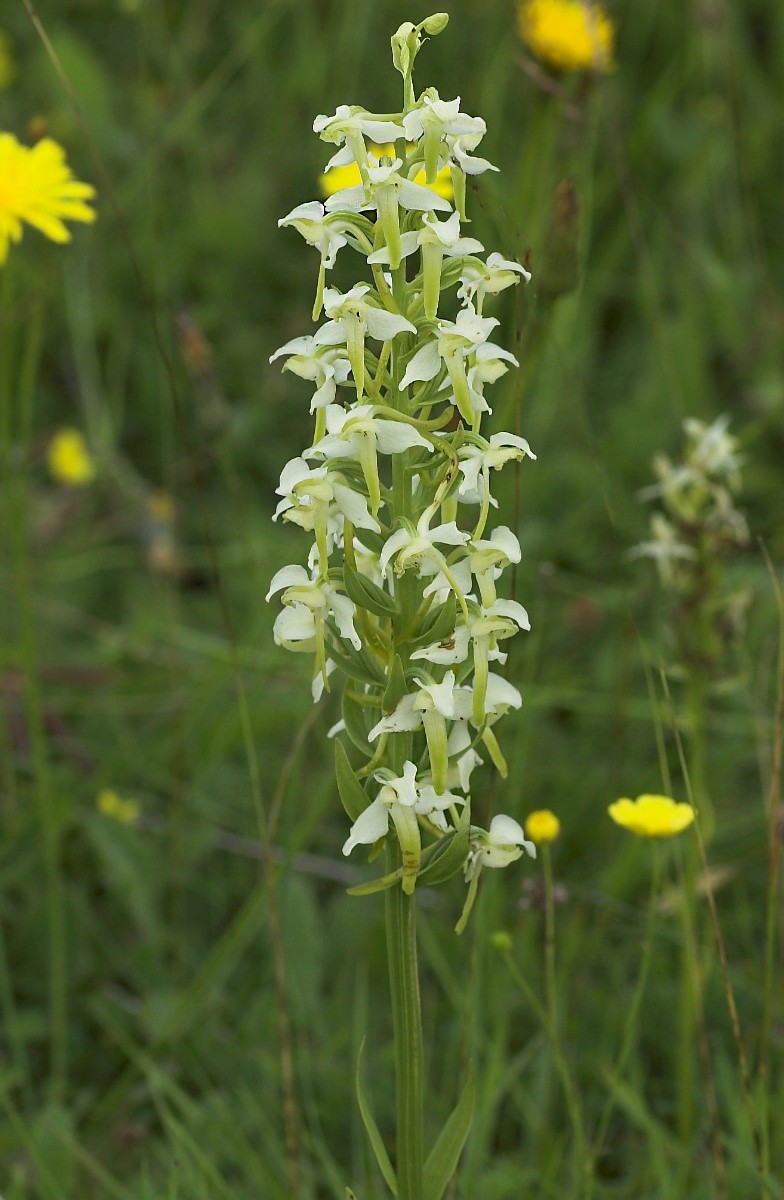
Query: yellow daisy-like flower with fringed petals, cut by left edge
[[0, 133, 95, 265]]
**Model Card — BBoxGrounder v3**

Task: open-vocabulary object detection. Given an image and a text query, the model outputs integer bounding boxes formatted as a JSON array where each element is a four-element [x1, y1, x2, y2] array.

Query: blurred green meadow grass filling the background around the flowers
[[0, 0, 784, 1200]]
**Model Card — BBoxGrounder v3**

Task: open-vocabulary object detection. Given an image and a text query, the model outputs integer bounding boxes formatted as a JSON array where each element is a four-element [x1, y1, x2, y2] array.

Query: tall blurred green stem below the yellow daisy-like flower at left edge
[[0, 264, 67, 1100]]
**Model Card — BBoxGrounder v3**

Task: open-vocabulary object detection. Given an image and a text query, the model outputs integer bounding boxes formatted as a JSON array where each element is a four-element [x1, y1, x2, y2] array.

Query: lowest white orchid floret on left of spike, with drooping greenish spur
[[343, 761, 441, 895]]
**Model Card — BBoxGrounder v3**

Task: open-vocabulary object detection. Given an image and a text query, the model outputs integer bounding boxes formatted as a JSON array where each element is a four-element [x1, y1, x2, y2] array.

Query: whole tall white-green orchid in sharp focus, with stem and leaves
[[268, 13, 535, 1200]]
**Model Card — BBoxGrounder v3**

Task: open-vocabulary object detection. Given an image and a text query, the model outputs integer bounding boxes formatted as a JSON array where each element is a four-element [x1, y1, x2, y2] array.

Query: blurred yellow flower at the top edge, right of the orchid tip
[[517, 0, 615, 72]]
